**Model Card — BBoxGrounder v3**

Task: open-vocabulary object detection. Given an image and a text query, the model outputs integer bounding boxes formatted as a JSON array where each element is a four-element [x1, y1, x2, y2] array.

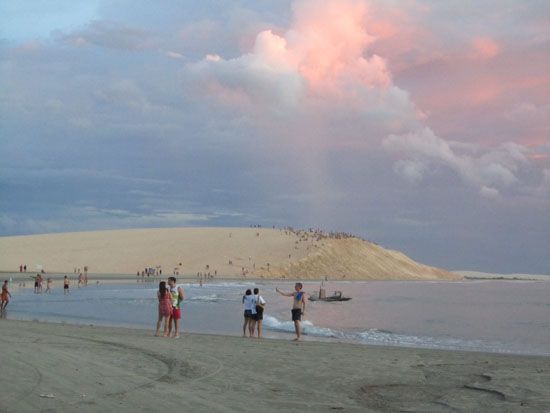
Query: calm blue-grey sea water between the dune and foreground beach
[[6, 280, 550, 355]]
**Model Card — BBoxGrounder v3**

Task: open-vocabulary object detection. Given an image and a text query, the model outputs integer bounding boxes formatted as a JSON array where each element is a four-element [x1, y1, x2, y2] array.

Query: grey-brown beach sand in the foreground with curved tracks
[[0, 320, 550, 412]]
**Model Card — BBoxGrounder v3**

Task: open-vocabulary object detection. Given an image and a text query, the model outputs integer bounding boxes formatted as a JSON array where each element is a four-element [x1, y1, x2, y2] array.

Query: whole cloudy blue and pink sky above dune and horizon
[[0, 0, 550, 274]]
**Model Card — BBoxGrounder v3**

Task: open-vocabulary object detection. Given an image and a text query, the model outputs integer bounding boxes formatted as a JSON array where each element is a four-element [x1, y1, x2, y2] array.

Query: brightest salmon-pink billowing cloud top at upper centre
[[190, 0, 392, 106]]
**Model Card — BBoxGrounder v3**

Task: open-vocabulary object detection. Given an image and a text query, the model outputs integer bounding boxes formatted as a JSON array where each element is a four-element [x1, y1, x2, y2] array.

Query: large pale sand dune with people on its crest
[[0, 228, 460, 280]]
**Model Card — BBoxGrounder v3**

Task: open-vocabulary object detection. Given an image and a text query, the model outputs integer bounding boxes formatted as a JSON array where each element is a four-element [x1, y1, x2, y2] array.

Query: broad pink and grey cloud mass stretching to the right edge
[[189, 0, 548, 198]]
